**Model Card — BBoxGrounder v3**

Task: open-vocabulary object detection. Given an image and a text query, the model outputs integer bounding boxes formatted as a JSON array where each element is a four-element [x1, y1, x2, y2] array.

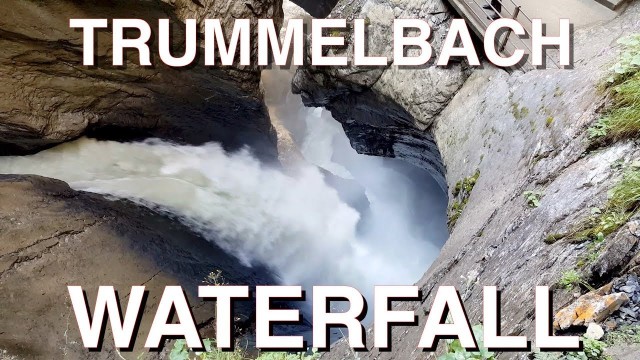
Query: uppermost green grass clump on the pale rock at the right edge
[[588, 34, 640, 141]]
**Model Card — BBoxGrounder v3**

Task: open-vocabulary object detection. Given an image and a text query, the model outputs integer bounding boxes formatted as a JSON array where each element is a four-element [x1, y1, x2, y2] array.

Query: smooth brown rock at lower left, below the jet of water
[[0, 175, 275, 359]]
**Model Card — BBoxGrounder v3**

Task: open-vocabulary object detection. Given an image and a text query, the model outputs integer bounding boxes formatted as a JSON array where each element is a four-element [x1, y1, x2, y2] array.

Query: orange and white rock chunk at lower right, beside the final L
[[553, 292, 629, 330]]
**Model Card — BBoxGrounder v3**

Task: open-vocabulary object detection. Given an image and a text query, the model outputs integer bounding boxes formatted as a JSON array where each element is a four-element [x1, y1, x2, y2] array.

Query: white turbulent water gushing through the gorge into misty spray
[[0, 67, 446, 293]]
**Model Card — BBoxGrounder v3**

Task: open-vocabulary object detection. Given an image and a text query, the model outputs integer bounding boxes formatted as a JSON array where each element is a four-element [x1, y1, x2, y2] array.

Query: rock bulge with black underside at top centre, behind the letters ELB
[[293, 0, 469, 187]]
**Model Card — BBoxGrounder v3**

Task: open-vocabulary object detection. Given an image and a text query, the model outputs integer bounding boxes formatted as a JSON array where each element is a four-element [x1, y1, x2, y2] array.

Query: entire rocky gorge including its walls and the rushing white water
[[0, 0, 640, 359]]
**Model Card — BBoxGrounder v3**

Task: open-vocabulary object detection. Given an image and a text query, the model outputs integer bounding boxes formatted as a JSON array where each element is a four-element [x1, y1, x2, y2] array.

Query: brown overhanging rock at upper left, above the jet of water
[[0, 0, 282, 159]]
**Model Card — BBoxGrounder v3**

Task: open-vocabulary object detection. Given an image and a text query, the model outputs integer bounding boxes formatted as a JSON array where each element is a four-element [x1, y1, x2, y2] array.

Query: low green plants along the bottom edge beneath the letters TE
[[169, 339, 320, 360]]
